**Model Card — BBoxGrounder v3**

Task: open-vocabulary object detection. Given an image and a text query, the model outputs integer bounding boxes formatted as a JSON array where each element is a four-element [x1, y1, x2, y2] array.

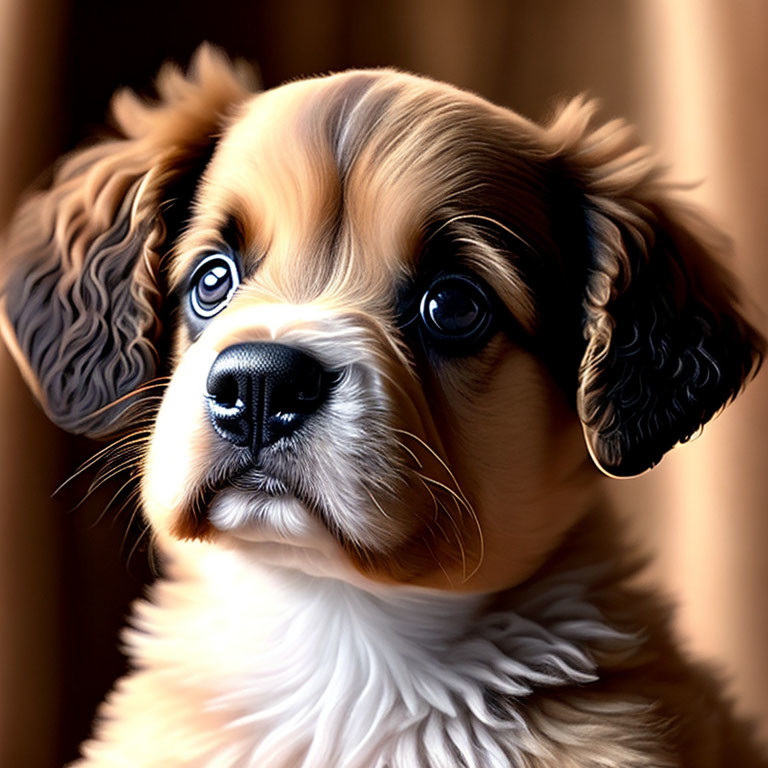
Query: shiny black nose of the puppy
[[206, 342, 333, 457]]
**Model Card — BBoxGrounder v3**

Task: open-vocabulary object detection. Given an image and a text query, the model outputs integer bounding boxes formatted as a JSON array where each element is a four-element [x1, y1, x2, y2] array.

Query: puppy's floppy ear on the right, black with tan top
[[549, 99, 764, 477]]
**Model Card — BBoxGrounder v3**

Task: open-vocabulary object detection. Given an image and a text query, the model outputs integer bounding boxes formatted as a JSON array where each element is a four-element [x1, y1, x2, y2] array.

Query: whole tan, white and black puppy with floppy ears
[[3, 47, 767, 768]]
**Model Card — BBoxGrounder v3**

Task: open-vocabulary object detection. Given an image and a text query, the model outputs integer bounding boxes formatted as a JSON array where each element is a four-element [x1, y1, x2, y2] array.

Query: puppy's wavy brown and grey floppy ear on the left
[[2, 46, 251, 435]]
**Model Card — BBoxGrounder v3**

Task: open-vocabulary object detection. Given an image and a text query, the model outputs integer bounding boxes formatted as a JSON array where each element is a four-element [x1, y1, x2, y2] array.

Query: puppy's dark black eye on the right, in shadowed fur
[[419, 275, 494, 355]]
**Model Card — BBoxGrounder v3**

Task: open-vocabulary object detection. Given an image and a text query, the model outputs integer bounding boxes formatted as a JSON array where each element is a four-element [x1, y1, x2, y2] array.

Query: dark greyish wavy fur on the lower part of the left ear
[[4, 176, 157, 433]]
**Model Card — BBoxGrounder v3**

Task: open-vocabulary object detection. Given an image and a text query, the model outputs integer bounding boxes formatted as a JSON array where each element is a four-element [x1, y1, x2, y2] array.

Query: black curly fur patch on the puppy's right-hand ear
[[583, 204, 764, 476]]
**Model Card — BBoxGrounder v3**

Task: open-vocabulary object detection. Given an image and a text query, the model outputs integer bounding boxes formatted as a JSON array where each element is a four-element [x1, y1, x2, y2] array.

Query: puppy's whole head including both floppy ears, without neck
[[3, 48, 762, 589]]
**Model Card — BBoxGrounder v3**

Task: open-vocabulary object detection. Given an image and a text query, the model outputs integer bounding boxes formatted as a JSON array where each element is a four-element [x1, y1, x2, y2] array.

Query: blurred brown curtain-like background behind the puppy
[[0, 0, 768, 768]]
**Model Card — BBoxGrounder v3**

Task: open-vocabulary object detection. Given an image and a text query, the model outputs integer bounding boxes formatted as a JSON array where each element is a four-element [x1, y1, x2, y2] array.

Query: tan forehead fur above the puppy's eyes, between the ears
[[175, 70, 548, 316]]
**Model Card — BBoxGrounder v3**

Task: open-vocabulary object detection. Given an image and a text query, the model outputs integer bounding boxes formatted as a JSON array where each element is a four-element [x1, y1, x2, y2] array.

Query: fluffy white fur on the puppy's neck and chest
[[106, 510, 672, 768]]
